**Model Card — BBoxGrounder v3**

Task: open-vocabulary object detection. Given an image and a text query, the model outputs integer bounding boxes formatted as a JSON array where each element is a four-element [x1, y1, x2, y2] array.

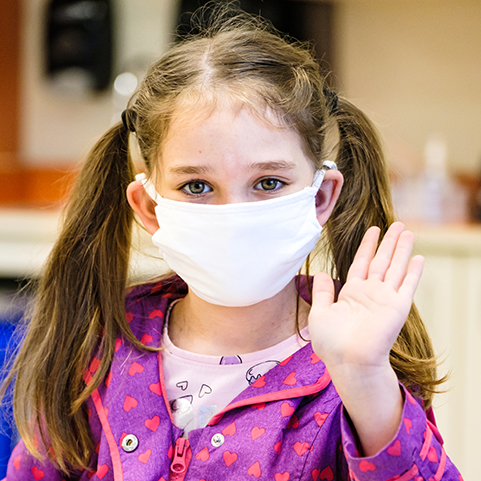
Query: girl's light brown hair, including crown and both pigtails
[[0, 5, 439, 472]]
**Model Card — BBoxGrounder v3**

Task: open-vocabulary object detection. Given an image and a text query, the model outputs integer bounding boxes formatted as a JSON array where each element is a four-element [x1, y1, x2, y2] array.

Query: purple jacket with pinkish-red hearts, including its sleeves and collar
[[6, 278, 462, 481]]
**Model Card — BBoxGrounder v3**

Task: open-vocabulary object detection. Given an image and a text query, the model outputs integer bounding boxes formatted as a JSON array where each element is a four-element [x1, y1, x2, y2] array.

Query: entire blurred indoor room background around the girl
[[0, 0, 481, 480]]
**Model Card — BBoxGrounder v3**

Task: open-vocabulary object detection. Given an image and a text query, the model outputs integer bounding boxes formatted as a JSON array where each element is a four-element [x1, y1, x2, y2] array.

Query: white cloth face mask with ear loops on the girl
[[136, 161, 337, 307]]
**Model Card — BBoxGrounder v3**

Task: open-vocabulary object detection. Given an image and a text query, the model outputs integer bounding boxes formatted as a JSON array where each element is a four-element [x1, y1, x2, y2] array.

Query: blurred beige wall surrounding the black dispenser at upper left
[[20, 0, 177, 166]]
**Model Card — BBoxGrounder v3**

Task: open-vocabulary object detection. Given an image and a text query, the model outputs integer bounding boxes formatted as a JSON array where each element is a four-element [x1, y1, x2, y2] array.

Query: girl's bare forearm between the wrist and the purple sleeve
[[328, 365, 404, 456]]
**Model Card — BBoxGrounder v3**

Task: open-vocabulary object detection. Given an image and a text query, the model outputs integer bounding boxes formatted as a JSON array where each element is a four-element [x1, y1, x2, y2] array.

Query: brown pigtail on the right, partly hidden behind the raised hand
[[326, 98, 444, 409]]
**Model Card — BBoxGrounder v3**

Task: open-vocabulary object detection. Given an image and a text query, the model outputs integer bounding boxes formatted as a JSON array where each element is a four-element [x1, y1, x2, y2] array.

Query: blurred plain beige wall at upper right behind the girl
[[335, 0, 481, 173]]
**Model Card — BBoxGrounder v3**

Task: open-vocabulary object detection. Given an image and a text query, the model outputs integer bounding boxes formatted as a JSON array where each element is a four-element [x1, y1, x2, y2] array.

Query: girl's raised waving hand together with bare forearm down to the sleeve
[[309, 222, 424, 456]]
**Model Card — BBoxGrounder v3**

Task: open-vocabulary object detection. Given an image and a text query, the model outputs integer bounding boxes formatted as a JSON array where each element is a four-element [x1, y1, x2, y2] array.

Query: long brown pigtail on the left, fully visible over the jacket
[[5, 123, 151, 473]]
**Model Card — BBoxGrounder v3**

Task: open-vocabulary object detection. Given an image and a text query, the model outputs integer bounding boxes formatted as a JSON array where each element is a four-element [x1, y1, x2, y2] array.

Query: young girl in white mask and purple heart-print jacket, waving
[[2, 4, 461, 481]]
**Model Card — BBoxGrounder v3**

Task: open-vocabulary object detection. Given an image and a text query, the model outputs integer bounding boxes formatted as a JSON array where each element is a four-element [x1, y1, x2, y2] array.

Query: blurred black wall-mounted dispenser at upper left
[[46, 0, 113, 92]]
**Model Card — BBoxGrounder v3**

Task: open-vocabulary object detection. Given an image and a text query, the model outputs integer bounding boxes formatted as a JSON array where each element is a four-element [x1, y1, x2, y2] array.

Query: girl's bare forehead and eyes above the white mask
[[156, 108, 314, 204]]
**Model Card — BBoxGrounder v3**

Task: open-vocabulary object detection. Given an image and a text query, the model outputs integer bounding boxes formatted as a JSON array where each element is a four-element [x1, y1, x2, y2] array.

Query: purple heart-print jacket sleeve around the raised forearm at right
[[341, 387, 463, 481]]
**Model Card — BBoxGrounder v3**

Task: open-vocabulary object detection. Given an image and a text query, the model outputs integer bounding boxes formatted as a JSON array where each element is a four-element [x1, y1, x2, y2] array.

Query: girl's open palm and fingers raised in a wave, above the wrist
[[309, 222, 424, 369]]
